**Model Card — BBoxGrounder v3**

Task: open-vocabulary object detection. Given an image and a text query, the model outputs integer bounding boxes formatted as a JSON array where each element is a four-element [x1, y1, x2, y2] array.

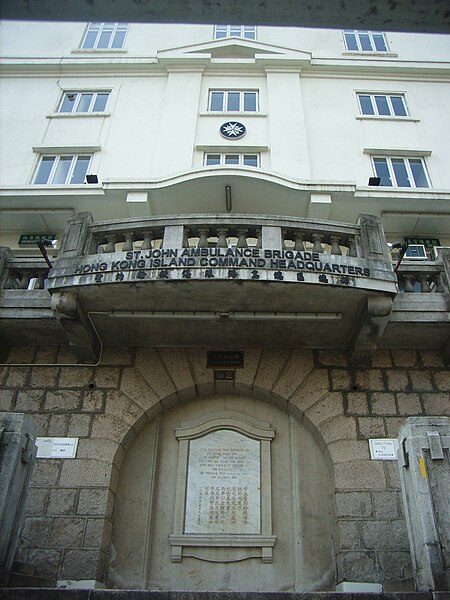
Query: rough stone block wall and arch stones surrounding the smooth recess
[[0, 347, 450, 590]]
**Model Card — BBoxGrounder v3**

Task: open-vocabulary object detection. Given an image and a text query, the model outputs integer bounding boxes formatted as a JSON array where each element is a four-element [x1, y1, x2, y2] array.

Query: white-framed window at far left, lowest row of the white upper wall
[[33, 154, 92, 185]]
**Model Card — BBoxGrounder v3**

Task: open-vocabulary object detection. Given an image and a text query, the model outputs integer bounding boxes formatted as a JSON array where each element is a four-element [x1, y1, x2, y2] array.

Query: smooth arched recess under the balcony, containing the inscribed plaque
[[108, 395, 334, 591]]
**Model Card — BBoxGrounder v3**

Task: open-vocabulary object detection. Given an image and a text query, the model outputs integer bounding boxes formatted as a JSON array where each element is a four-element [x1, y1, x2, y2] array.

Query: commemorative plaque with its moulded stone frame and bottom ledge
[[169, 411, 276, 563]]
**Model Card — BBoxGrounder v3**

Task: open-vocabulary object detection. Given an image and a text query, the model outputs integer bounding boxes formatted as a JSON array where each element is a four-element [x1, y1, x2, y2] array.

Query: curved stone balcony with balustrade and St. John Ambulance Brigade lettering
[[0, 213, 449, 364]]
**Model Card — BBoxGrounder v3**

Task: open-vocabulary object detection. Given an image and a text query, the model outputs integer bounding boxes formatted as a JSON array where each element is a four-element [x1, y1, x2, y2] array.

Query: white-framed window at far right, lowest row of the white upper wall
[[373, 157, 431, 188]]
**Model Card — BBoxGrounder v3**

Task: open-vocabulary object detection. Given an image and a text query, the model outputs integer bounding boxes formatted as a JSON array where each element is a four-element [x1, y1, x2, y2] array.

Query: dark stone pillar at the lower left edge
[[0, 412, 36, 587]]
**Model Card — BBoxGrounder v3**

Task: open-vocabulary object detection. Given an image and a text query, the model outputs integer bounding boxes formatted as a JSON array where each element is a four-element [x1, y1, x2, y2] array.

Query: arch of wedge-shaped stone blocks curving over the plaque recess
[[82, 349, 356, 588]]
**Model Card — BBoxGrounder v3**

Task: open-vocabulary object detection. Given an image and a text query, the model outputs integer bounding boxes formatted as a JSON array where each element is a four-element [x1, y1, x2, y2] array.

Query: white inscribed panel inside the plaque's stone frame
[[184, 429, 261, 534]]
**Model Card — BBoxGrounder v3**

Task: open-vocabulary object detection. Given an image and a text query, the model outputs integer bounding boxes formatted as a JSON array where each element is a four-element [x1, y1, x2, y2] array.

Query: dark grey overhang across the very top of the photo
[[0, 0, 450, 33]]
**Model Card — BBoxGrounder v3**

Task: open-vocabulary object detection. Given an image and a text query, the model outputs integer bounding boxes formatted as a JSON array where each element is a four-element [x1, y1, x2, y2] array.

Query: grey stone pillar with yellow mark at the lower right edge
[[399, 417, 450, 591]]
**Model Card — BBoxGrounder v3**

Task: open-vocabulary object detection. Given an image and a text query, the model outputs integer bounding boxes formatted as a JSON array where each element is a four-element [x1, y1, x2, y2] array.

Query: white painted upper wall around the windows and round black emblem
[[0, 22, 450, 243]]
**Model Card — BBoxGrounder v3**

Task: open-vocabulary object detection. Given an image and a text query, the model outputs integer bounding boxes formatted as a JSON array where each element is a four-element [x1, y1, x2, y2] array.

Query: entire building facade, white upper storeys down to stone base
[[0, 22, 450, 591]]
